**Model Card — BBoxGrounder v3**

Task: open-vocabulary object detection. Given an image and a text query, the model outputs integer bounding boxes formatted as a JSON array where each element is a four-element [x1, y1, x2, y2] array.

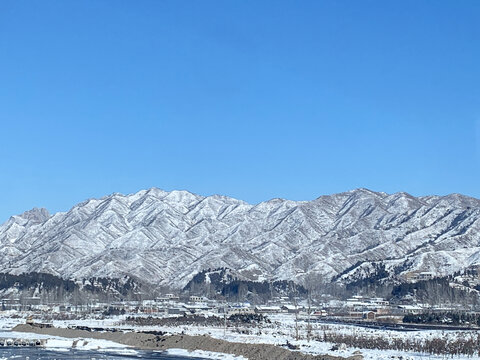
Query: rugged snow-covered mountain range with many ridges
[[0, 188, 480, 287]]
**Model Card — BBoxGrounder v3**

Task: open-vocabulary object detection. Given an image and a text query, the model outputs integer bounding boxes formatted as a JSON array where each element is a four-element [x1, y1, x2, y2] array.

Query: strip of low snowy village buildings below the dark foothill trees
[[0, 293, 477, 327]]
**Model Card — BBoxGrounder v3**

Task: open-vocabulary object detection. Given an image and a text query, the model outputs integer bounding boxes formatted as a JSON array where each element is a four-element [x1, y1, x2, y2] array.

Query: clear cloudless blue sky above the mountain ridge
[[0, 0, 480, 222]]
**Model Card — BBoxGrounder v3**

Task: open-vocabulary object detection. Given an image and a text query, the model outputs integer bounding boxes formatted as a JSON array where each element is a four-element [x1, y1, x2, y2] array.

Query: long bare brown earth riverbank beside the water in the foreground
[[12, 324, 363, 360]]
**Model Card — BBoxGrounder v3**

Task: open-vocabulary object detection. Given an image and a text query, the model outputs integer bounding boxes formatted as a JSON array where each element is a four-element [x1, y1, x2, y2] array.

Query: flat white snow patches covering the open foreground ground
[[0, 314, 480, 360]]
